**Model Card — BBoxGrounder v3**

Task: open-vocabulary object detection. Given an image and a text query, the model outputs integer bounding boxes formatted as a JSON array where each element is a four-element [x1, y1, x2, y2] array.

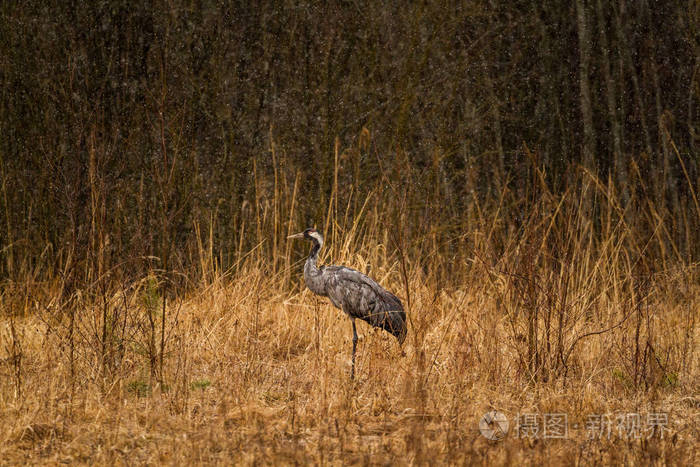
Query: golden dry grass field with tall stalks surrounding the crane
[[0, 145, 700, 465]]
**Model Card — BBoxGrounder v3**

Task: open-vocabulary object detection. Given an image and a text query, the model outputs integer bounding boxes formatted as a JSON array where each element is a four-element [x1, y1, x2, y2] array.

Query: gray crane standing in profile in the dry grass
[[287, 229, 406, 379]]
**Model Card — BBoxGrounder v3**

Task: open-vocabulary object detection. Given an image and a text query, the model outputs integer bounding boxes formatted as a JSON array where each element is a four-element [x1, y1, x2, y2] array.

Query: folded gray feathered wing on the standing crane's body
[[322, 266, 406, 343]]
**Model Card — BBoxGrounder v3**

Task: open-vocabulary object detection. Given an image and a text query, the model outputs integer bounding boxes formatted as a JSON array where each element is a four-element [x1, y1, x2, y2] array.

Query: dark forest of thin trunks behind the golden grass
[[0, 0, 700, 290]]
